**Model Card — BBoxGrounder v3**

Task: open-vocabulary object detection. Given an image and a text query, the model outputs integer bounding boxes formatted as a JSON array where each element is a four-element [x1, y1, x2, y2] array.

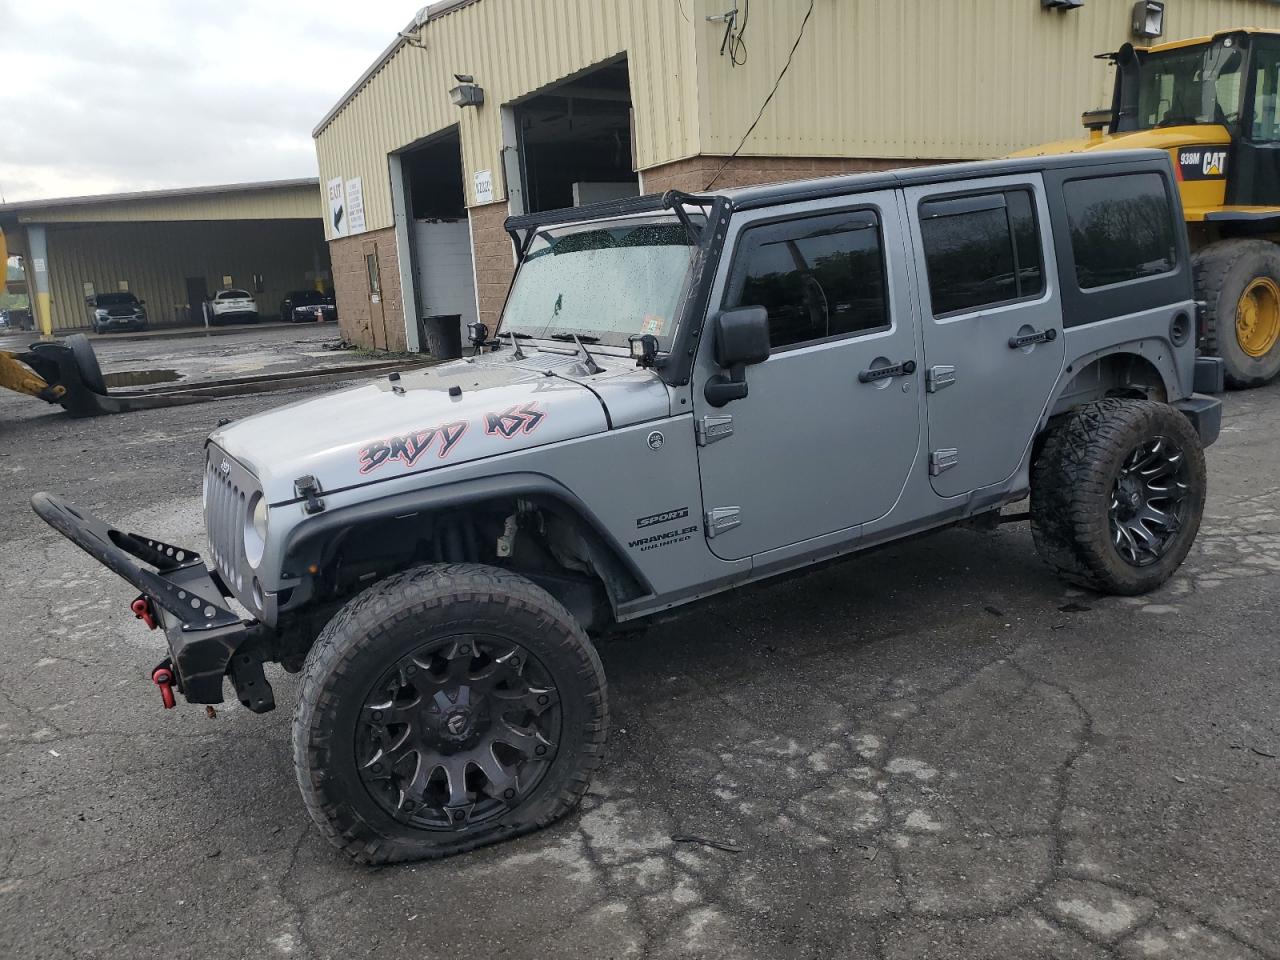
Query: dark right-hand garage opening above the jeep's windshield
[[515, 59, 640, 212]]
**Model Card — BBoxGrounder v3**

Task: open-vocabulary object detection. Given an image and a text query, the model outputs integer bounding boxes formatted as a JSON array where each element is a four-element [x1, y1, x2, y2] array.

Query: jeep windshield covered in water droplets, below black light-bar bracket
[[498, 218, 698, 348]]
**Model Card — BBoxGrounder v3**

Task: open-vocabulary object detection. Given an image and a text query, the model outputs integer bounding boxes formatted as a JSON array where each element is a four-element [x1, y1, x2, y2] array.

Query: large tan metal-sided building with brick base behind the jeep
[[314, 0, 1280, 349]]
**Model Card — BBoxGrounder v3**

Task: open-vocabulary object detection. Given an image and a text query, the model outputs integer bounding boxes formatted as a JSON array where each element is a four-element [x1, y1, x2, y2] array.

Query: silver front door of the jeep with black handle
[[692, 191, 920, 559]]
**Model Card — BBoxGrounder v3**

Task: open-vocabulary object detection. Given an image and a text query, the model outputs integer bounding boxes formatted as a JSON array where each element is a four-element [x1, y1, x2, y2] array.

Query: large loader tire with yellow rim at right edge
[[1193, 239, 1280, 389]]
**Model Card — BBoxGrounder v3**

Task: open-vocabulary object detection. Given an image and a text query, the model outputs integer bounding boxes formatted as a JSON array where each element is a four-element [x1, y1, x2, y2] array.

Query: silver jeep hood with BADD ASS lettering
[[209, 344, 671, 504]]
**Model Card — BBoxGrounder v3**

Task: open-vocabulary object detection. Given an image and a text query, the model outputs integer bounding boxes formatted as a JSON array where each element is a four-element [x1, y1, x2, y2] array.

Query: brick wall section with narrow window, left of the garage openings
[[329, 228, 406, 352]]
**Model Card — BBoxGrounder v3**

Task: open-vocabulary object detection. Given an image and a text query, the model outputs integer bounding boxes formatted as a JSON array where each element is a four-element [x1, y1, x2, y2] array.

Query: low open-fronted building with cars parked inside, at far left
[[0, 179, 330, 334]]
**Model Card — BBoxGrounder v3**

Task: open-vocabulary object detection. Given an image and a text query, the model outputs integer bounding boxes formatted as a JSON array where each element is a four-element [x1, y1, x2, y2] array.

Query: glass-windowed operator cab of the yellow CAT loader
[[1110, 31, 1280, 209]]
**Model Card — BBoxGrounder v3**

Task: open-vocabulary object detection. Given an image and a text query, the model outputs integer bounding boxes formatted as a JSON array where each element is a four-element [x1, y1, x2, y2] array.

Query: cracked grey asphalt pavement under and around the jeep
[[0, 343, 1280, 960]]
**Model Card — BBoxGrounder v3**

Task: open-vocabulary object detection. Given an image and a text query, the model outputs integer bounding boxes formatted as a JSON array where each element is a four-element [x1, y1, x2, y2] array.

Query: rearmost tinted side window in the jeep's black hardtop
[[1062, 173, 1178, 289]]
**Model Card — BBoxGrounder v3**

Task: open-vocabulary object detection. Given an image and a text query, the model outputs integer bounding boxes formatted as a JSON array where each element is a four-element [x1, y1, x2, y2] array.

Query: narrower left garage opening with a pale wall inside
[[401, 127, 477, 348]]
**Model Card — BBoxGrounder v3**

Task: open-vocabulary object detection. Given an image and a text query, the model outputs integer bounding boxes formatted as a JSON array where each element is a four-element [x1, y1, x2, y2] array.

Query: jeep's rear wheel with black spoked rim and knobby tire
[[1032, 399, 1206, 595]]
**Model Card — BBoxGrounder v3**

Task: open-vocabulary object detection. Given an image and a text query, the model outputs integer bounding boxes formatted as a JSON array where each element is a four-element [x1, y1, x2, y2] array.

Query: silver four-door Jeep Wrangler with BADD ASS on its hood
[[33, 151, 1222, 863]]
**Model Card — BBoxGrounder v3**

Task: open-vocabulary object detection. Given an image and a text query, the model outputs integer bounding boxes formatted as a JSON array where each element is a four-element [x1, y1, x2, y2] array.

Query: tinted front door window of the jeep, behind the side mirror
[[724, 210, 890, 348]]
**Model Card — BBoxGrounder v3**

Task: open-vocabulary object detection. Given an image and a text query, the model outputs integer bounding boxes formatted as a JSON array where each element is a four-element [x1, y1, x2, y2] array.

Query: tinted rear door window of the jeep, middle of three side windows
[[920, 189, 1044, 316]]
